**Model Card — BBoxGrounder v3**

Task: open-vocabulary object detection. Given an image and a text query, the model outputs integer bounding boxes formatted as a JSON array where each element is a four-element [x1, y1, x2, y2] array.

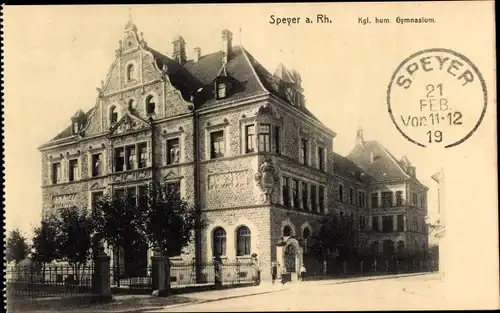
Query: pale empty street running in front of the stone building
[[149, 274, 448, 312]]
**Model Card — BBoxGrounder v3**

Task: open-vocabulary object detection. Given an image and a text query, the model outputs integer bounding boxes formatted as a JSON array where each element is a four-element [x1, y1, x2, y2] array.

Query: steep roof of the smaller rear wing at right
[[347, 140, 422, 184]]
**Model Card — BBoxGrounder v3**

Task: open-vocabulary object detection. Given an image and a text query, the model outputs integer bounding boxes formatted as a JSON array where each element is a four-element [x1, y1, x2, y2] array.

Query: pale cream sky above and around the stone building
[[4, 3, 496, 246]]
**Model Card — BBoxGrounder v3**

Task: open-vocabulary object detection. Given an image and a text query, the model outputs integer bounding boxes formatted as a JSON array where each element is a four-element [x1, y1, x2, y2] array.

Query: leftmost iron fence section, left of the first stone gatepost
[[5, 264, 94, 298]]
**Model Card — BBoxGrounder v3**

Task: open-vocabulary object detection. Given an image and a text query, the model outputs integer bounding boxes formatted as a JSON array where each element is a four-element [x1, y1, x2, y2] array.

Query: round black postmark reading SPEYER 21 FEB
[[387, 48, 488, 148]]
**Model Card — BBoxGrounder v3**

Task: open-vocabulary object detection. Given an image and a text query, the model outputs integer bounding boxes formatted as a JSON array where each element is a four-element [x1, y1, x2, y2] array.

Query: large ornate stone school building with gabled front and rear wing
[[39, 20, 427, 278]]
